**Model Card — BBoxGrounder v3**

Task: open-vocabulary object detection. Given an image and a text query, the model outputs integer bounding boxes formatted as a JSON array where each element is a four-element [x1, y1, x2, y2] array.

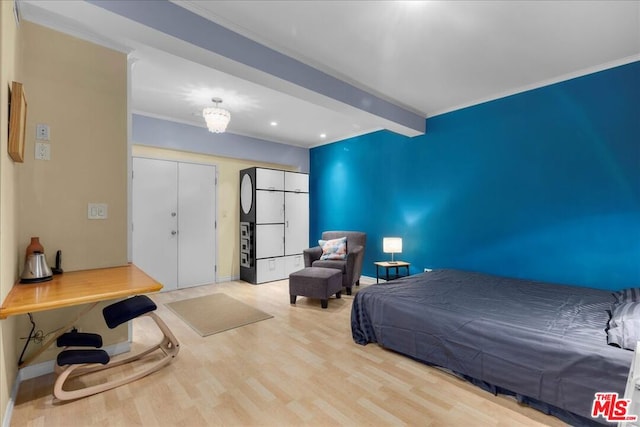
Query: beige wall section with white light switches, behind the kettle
[[18, 21, 127, 271]]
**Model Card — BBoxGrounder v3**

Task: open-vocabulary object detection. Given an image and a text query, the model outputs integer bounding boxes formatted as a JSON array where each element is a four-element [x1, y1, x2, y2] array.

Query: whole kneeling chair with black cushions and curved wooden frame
[[53, 295, 180, 400]]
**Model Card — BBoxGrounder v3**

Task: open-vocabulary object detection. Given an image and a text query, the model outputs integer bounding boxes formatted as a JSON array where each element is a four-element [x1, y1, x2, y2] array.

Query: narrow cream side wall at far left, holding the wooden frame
[[0, 1, 20, 423]]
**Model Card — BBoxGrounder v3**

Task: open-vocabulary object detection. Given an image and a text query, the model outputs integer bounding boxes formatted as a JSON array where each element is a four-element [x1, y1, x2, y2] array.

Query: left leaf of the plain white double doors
[[132, 158, 178, 291]]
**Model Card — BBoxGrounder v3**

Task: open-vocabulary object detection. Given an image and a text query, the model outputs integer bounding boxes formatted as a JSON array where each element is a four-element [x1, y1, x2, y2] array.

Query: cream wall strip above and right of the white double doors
[[132, 145, 296, 281]]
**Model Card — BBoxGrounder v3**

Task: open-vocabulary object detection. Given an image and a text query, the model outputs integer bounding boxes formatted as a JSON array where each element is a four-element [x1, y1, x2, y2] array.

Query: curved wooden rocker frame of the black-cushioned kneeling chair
[[53, 311, 180, 400]]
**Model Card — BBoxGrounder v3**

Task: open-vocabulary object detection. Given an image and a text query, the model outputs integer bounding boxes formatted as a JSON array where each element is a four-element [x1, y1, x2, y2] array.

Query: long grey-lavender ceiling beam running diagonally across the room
[[87, 0, 426, 136]]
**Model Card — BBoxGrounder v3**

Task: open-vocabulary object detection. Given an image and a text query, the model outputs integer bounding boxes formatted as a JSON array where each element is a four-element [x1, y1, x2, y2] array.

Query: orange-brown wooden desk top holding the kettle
[[0, 264, 162, 319]]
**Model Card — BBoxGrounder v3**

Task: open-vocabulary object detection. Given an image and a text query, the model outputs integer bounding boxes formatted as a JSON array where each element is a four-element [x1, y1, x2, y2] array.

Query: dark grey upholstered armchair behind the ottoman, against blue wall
[[303, 231, 367, 295]]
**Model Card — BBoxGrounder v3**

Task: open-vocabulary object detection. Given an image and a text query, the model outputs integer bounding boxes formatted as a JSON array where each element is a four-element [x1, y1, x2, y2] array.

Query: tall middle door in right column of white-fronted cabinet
[[284, 193, 309, 255]]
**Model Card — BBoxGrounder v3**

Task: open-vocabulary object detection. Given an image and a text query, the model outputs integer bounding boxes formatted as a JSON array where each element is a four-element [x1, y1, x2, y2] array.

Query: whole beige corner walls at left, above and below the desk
[[0, 20, 128, 424]]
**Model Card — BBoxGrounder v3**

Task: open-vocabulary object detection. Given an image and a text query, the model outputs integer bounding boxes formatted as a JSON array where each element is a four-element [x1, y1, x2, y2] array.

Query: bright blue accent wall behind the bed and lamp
[[310, 62, 640, 289]]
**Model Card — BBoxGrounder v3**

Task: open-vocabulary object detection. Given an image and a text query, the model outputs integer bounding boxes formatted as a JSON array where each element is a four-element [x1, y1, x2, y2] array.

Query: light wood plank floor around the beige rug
[[11, 281, 564, 427]]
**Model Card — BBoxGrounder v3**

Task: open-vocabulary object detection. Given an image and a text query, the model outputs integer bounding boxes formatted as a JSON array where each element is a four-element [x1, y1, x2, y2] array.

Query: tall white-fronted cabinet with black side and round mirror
[[240, 168, 309, 284]]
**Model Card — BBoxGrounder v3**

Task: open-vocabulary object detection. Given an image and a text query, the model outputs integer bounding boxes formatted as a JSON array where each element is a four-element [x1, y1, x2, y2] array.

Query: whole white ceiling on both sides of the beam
[[18, 0, 640, 147]]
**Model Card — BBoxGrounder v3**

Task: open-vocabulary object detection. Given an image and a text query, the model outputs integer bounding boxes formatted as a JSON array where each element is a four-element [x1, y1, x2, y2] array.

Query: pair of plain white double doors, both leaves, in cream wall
[[132, 157, 216, 291]]
